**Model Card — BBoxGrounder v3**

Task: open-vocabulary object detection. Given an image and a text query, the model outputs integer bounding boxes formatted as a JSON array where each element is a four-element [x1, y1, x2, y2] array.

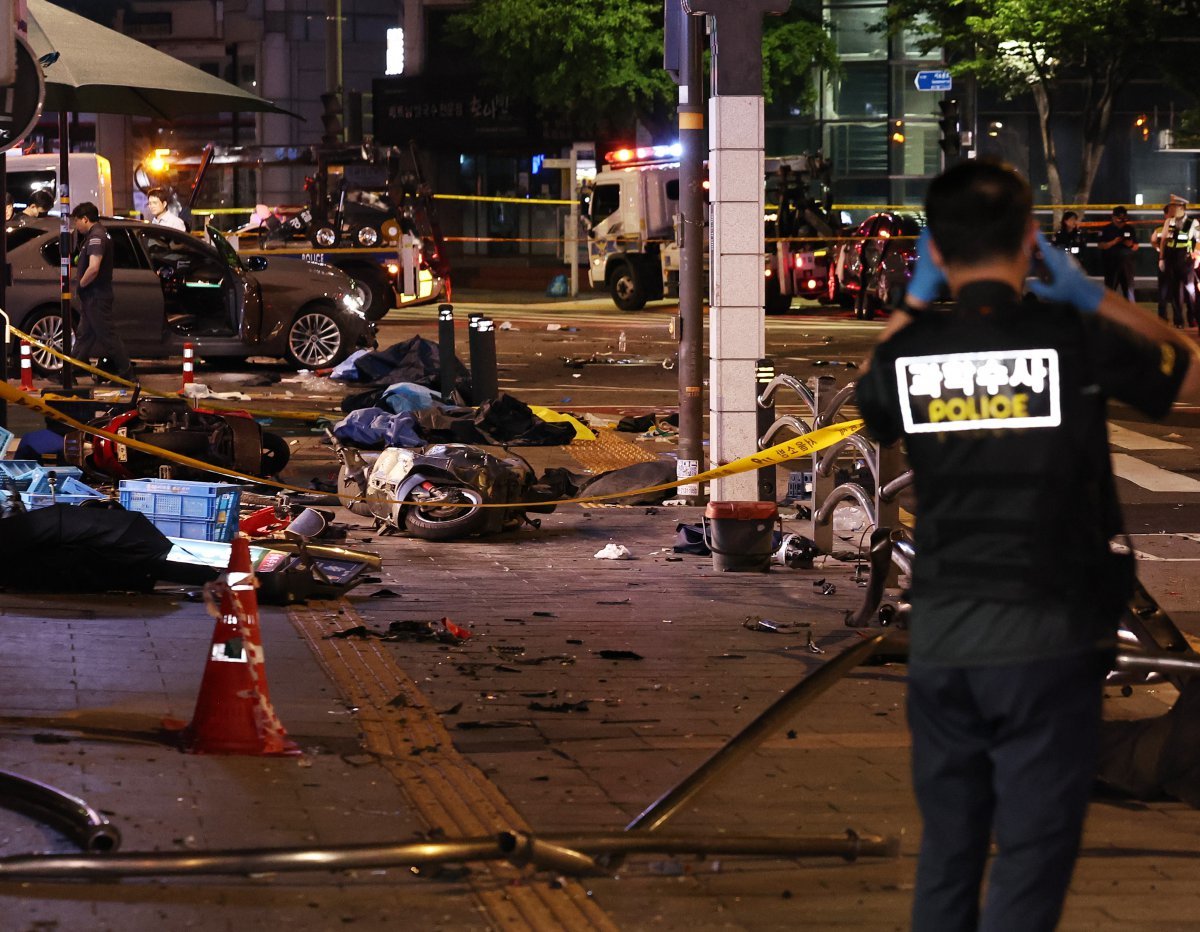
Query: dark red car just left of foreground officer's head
[[828, 212, 923, 320]]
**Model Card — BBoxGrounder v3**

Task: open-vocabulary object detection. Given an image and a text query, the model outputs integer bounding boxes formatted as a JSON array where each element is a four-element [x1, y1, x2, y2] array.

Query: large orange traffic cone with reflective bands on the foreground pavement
[[177, 536, 300, 754]]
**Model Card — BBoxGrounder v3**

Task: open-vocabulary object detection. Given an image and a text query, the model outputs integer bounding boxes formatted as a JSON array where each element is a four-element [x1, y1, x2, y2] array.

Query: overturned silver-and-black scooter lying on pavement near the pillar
[[330, 433, 556, 541]]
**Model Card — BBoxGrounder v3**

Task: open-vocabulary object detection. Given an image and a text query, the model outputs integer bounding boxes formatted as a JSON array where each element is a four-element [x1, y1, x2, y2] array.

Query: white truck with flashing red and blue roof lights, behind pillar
[[586, 145, 833, 313]]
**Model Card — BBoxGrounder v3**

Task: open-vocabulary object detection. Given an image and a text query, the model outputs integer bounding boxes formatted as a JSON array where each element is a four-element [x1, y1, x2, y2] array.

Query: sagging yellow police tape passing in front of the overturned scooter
[[0, 381, 863, 509]]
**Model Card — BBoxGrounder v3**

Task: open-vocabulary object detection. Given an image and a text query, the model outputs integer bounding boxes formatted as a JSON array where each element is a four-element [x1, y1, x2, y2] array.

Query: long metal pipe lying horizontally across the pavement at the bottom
[[0, 830, 899, 882]]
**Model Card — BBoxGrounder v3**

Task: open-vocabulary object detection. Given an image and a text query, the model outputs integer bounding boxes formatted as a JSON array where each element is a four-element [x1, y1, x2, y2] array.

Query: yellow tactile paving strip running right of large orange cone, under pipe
[[288, 597, 619, 932]]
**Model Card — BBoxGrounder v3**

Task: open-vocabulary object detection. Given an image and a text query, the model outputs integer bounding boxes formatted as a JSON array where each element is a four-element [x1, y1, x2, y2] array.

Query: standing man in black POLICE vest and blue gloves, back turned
[[857, 161, 1200, 932]]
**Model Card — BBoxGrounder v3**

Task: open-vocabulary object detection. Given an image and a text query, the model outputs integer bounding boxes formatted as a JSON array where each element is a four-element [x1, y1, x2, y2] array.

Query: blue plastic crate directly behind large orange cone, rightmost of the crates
[[119, 479, 241, 543]]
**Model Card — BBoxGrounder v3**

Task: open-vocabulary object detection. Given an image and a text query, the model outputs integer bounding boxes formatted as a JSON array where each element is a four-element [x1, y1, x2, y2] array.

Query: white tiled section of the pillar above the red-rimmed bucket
[[708, 95, 766, 501]]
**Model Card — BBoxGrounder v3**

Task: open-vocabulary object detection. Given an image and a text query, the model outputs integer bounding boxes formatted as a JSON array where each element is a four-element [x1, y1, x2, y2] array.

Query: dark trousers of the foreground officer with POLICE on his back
[[908, 654, 1109, 932]]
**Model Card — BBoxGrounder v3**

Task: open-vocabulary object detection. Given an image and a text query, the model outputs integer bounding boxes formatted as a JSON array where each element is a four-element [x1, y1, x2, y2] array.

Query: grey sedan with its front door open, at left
[[6, 217, 374, 375]]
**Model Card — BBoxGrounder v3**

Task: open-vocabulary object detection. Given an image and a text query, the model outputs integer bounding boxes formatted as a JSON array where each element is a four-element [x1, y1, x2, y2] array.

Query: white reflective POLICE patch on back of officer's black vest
[[895, 349, 1062, 433]]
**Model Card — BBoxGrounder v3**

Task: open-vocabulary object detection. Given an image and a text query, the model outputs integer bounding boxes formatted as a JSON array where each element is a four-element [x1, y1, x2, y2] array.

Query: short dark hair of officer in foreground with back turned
[[925, 158, 1033, 265]]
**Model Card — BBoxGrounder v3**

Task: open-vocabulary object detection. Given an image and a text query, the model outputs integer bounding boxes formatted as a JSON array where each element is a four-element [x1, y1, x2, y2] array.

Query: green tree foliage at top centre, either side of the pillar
[[450, 0, 836, 137]]
